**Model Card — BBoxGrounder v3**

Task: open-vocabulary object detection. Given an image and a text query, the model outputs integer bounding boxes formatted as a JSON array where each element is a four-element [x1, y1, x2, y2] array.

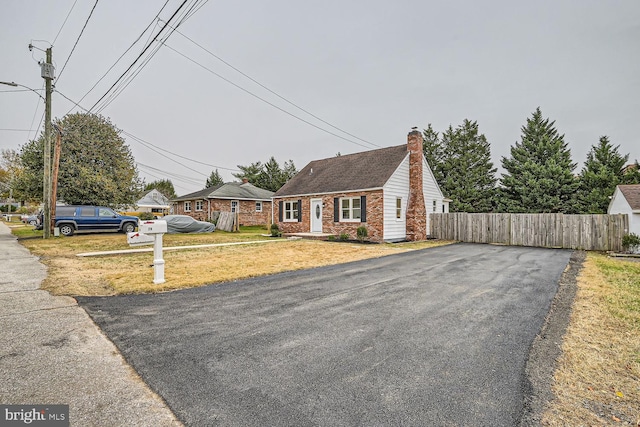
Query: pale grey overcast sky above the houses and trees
[[0, 0, 640, 194]]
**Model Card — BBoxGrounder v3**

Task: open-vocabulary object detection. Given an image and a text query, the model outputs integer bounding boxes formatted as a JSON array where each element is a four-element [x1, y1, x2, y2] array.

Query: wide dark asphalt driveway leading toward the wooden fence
[[78, 244, 571, 426]]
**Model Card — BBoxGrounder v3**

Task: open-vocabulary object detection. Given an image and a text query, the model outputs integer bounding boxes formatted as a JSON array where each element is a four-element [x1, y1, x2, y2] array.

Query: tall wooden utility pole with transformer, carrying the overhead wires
[[40, 47, 54, 239]]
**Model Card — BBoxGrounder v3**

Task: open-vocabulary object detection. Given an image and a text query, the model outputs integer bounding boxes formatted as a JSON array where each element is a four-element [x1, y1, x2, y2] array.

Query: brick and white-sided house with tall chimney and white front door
[[273, 130, 450, 242]]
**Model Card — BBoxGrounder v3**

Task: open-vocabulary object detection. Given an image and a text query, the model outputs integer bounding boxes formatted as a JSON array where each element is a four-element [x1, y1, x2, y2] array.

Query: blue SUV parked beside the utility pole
[[38, 206, 138, 236]]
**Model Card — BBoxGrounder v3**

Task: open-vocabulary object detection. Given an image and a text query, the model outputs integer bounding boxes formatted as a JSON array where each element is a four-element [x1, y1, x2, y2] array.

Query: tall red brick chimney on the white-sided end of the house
[[407, 128, 427, 241]]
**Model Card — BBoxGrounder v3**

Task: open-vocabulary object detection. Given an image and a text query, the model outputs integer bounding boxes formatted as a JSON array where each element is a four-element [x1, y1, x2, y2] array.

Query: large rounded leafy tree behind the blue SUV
[[16, 113, 142, 208]]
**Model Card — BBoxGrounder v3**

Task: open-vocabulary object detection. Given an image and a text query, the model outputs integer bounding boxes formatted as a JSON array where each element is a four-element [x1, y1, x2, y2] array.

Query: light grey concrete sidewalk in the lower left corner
[[0, 222, 182, 426]]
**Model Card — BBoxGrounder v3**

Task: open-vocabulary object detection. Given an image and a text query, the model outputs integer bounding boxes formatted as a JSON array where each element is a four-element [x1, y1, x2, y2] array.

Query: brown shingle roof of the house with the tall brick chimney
[[274, 144, 409, 197]]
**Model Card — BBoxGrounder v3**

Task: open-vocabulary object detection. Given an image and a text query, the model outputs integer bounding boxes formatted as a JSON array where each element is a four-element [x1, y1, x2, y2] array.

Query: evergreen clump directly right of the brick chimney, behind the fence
[[423, 119, 497, 212]]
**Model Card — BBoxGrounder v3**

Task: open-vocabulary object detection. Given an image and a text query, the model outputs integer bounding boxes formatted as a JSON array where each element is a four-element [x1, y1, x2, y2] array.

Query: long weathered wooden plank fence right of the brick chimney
[[430, 213, 629, 252]]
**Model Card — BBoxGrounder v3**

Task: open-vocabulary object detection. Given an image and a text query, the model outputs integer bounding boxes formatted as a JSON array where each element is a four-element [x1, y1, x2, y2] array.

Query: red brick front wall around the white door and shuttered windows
[[273, 190, 384, 242]]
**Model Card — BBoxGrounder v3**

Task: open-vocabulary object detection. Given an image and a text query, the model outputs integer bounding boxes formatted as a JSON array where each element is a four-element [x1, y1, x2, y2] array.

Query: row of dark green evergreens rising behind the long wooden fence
[[423, 108, 640, 214]]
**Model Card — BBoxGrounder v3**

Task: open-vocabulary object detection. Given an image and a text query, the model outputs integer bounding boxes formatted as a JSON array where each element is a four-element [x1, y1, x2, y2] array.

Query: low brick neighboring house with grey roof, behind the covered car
[[171, 180, 273, 225]]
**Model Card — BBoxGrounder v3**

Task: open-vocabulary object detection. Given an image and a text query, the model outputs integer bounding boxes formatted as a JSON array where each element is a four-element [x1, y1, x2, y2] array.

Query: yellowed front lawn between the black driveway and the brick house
[[12, 227, 450, 295]]
